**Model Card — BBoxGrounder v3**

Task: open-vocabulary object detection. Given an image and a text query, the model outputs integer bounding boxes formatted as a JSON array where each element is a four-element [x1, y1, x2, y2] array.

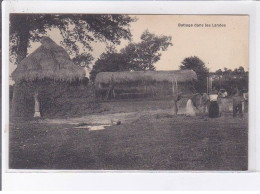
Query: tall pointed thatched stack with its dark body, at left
[[11, 37, 85, 117]]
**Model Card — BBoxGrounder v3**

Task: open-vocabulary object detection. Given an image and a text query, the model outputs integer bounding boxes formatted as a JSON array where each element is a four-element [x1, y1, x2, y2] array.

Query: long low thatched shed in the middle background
[[95, 70, 197, 99]]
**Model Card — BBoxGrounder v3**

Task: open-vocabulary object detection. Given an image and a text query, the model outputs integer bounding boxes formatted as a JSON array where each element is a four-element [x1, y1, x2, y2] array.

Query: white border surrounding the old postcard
[[2, 1, 260, 190]]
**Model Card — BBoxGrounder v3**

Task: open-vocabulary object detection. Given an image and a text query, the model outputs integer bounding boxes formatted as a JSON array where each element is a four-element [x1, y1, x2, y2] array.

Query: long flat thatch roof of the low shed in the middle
[[95, 70, 197, 84]]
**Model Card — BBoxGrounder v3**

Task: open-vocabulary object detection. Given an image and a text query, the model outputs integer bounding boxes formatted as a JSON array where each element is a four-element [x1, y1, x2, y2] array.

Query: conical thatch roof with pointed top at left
[[12, 37, 86, 82]]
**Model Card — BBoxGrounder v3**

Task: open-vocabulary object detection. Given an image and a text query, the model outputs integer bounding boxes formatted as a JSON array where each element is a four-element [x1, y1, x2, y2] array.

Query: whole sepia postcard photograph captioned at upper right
[[8, 13, 249, 171]]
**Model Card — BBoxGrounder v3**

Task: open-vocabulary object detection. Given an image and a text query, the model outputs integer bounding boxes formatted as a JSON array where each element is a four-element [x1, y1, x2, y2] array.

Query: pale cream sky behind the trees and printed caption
[[10, 15, 249, 80]]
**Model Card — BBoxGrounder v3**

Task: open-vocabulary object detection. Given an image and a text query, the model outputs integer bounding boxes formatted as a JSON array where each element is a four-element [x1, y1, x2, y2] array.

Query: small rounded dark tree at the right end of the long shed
[[180, 56, 209, 93]]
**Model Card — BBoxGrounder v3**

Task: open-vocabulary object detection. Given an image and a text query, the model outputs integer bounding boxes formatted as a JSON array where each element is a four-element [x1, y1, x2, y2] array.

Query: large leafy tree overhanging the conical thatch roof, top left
[[10, 14, 136, 64]]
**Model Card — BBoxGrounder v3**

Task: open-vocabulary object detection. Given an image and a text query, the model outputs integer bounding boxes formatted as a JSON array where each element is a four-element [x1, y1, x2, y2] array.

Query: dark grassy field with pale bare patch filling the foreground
[[9, 100, 248, 170]]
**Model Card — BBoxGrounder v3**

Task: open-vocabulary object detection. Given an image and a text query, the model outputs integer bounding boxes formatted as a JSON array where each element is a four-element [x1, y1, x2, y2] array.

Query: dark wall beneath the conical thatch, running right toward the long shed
[[11, 80, 95, 118]]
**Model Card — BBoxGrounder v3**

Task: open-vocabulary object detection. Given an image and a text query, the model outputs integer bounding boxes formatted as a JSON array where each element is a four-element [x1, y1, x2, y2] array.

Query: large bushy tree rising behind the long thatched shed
[[90, 30, 172, 81]]
